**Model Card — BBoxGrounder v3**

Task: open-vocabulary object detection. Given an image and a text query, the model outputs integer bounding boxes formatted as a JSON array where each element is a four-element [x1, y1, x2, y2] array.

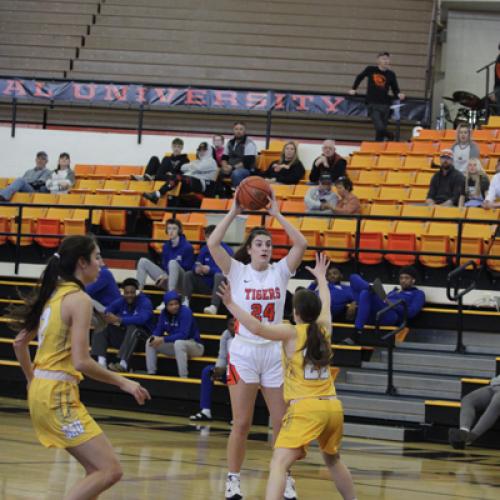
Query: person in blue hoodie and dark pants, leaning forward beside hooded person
[[91, 278, 154, 372]]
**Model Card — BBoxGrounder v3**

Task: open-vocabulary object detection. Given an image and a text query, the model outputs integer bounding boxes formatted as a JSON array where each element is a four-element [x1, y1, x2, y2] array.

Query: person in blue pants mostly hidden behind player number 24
[[189, 317, 235, 422]]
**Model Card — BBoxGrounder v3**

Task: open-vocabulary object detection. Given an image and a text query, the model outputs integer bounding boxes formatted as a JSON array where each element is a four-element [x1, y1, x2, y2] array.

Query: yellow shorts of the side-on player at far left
[[28, 378, 102, 448]]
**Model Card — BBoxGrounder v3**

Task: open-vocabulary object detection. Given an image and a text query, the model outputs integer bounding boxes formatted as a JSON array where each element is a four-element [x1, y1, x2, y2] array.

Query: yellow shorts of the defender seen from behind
[[274, 398, 344, 455]]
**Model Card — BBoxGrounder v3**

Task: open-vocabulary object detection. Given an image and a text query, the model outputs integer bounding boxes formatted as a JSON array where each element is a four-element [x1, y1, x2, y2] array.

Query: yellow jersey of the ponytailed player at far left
[[34, 281, 83, 380]]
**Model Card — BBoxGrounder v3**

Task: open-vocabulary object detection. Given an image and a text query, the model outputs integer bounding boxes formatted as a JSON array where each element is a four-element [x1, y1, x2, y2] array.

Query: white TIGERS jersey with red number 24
[[227, 257, 293, 344]]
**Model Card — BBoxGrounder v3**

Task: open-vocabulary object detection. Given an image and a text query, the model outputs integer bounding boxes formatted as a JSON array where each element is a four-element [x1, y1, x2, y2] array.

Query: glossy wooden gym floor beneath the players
[[0, 398, 500, 500]]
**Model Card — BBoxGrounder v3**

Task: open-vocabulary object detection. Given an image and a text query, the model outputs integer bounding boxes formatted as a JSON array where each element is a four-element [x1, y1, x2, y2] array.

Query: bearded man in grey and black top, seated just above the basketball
[[221, 122, 257, 187]]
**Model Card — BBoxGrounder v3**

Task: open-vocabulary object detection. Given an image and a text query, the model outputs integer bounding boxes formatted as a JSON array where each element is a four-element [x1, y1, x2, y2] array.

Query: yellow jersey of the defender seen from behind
[[282, 324, 335, 402]]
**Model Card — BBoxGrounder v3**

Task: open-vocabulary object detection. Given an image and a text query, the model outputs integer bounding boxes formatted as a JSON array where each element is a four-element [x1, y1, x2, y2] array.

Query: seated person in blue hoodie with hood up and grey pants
[[146, 290, 205, 378]]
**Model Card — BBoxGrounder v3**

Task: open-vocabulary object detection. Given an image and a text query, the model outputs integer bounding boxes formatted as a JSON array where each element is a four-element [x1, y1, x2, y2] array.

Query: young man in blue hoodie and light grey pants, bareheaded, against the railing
[[137, 219, 194, 296]]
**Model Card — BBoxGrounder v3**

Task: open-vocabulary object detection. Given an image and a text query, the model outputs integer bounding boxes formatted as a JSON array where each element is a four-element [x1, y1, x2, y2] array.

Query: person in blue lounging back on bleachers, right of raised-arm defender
[[343, 266, 425, 345]]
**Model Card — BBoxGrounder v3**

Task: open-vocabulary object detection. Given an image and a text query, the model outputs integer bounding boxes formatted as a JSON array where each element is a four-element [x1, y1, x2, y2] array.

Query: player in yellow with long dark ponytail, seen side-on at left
[[12, 236, 150, 500]]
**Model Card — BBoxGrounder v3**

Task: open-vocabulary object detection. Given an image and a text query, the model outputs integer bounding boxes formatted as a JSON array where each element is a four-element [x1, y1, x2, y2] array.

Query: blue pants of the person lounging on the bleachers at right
[[350, 274, 400, 330]]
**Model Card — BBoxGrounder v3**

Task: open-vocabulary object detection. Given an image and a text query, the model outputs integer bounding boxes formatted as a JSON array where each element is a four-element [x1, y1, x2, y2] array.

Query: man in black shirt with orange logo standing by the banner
[[349, 52, 405, 141]]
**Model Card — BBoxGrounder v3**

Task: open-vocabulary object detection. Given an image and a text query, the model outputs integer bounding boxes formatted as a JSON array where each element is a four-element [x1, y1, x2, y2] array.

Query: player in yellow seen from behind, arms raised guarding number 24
[[219, 254, 356, 500]]
